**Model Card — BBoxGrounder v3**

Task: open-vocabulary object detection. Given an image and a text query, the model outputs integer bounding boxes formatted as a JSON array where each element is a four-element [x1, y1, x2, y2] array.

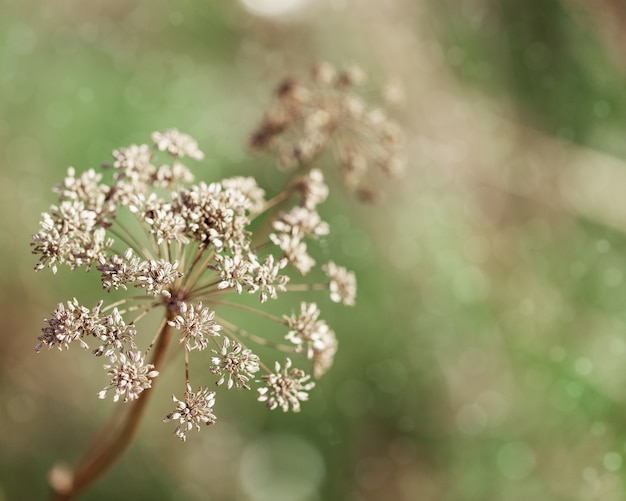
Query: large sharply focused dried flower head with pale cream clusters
[[32, 130, 356, 446]]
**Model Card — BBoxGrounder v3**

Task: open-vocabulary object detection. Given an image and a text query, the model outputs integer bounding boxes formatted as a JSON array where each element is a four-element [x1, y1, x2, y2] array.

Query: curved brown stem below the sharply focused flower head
[[50, 320, 172, 501]]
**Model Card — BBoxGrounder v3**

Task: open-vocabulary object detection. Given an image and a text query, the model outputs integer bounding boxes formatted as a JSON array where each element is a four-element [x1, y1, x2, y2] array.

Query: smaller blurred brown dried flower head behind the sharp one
[[250, 63, 404, 201]]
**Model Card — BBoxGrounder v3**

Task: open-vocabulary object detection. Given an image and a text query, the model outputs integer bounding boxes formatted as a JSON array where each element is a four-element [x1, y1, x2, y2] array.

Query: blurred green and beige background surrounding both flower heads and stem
[[0, 0, 626, 501]]
